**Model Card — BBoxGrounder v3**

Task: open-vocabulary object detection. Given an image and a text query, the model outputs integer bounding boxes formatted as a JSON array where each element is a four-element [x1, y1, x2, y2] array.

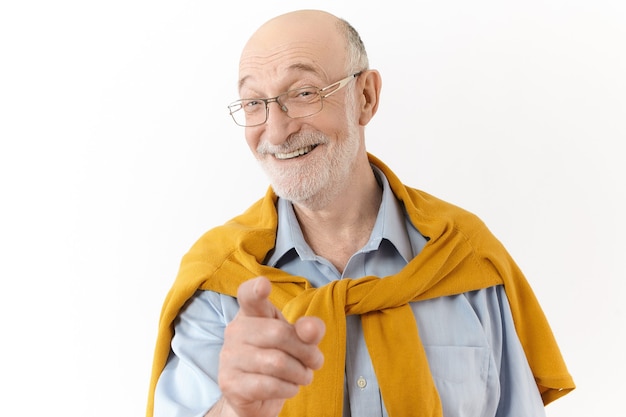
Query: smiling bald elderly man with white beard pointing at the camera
[[148, 10, 574, 417]]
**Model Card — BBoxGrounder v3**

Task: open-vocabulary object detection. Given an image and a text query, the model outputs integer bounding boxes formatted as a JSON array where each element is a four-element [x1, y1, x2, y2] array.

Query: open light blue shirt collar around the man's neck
[[266, 165, 413, 266]]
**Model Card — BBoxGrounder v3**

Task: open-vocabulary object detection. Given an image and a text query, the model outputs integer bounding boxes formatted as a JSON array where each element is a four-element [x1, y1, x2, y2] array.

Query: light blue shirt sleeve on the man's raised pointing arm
[[154, 291, 239, 417]]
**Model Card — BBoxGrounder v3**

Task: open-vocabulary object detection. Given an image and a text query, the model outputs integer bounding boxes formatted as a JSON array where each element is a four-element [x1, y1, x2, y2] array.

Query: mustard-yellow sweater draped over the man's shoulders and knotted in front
[[147, 155, 575, 417]]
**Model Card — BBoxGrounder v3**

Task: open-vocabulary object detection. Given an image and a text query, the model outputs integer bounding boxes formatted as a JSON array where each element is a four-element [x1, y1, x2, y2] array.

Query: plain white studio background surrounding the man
[[0, 0, 626, 417]]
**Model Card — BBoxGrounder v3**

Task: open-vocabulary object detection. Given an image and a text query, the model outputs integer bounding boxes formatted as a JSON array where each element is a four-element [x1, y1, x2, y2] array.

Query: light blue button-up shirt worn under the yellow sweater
[[154, 167, 545, 417]]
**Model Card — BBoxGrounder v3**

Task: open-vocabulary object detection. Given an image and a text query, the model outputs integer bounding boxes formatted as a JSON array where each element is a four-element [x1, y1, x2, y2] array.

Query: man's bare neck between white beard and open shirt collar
[[294, 162, 382, 272]]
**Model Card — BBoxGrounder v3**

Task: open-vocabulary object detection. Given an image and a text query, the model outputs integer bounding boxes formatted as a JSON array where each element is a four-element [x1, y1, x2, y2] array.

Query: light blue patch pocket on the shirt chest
[[425, 346, 499, 417]]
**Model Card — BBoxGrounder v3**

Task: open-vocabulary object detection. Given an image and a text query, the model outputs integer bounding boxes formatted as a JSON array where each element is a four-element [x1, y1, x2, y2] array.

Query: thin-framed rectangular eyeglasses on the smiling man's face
[[228, 71, 362, 127]]
